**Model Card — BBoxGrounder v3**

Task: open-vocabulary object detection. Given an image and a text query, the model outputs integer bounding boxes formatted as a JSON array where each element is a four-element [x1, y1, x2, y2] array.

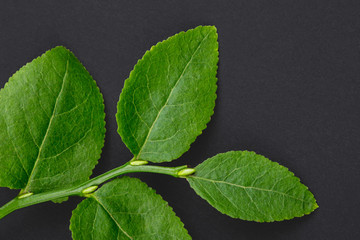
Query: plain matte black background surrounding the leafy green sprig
[[0, 0, 360, 240]]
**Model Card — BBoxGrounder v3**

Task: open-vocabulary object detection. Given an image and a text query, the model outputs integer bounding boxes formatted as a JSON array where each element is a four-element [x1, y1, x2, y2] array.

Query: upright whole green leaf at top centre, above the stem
[[116, 26, 218, 162]]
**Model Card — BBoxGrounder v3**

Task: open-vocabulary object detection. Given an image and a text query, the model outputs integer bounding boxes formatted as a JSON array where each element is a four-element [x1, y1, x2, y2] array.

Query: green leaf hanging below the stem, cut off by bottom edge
[[70, 177, 191, 240]]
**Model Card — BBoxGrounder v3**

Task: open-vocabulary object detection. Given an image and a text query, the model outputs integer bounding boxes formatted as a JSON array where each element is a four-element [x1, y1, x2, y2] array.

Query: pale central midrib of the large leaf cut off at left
[[22, 59, 69, 192]]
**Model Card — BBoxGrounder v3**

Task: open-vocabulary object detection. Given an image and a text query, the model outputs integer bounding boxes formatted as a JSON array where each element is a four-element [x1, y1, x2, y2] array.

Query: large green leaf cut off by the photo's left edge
[[0, 47, 105, 193]]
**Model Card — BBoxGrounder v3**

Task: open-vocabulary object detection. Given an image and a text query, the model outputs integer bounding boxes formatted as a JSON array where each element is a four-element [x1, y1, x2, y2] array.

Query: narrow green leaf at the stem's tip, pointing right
[[187, 151, 318, 222]]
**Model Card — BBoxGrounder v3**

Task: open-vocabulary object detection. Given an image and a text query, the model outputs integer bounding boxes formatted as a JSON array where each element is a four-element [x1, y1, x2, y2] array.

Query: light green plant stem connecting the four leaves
[[0, 162, 187, 219]]
